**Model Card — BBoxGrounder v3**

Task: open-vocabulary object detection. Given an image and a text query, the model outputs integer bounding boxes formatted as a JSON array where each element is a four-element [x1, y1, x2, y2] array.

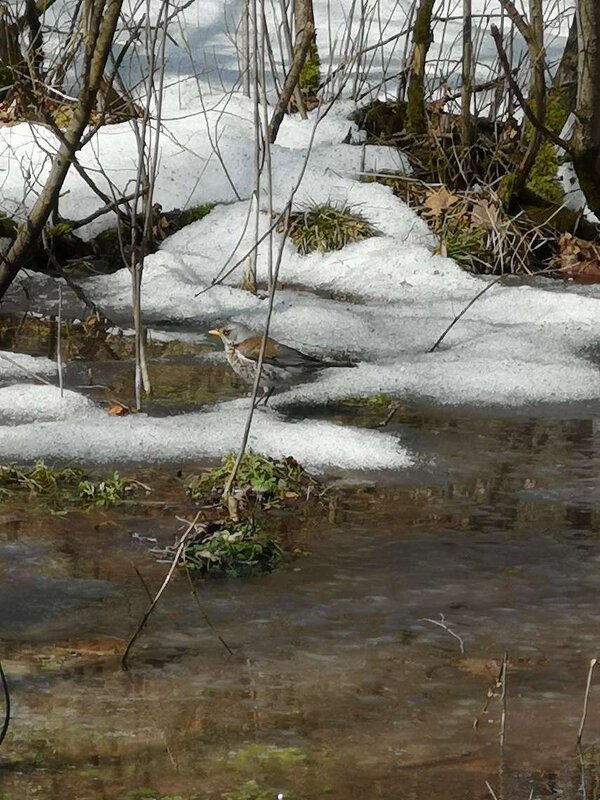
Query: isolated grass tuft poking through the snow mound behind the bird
[[278, 204, 380, 255]]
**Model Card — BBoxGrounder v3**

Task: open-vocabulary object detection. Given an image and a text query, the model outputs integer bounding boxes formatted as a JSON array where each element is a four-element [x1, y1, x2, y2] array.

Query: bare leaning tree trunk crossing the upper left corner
[[0, 0, 123, 300]]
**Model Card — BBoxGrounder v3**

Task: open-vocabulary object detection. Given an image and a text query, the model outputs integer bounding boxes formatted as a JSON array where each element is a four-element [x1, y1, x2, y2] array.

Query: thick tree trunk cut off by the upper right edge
[[572, 0, 600, 217]]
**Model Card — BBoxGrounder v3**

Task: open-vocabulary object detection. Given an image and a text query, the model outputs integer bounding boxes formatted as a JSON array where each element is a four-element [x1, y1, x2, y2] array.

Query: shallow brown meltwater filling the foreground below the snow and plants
[[0, 412, 600, 800]]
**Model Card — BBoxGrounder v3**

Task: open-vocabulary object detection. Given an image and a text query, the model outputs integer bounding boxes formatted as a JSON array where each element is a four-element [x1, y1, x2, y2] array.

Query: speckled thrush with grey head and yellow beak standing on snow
[[209, 322, 356, 405]]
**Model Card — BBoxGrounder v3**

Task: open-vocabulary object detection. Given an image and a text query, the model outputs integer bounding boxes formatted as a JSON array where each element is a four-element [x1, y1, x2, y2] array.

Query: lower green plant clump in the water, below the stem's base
[[185, 520, 281, 577]]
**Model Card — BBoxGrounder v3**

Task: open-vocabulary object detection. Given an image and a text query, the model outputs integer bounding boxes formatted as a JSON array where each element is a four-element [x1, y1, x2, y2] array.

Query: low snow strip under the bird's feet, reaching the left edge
[[0, 385, 412, 471]]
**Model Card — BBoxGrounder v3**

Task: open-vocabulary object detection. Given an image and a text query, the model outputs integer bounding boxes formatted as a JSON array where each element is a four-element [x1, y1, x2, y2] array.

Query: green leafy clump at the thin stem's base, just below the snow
[[187, 452, 320, 502]]
